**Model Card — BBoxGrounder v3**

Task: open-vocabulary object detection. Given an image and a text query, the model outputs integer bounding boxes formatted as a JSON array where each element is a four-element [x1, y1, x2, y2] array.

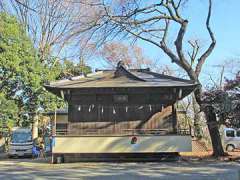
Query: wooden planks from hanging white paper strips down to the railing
[[68, 105, 173, 135]]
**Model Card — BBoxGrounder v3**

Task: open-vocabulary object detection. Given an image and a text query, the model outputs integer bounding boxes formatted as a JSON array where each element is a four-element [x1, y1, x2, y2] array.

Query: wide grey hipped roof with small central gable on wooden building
[[45, 64, 197, 89]]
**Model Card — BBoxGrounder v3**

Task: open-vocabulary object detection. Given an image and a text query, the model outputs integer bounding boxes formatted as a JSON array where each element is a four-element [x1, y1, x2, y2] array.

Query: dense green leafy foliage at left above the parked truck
[[0, 13, 91, 126]]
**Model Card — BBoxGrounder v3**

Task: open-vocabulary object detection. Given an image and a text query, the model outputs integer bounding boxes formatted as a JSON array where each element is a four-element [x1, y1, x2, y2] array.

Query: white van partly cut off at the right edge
[[222, 128, 240, 152]]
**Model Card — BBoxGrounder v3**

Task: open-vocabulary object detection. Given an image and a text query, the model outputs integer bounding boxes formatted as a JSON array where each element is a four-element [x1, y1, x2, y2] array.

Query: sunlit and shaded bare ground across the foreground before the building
[[0, 159, 240, 180]]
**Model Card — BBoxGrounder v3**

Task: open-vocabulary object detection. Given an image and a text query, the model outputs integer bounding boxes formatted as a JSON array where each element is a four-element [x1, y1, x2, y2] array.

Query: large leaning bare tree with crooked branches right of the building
[[67, 0, 224, 156]]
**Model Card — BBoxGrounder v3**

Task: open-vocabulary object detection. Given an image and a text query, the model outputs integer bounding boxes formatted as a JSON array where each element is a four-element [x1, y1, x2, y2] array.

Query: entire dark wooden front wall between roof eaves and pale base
[[65, 91, 176, 135]]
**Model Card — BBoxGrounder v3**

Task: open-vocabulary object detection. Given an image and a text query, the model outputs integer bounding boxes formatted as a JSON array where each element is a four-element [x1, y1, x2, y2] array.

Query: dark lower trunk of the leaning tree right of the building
[[204, 106, 224, 157]]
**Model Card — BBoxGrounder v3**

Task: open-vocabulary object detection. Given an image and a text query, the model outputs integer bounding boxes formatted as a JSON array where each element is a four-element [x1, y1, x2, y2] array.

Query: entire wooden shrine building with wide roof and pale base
[[45, 63, 197, 163]]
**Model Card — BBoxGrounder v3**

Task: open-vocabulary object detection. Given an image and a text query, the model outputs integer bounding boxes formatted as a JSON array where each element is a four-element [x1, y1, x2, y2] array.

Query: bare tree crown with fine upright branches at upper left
[[3, 0, 102, 62]]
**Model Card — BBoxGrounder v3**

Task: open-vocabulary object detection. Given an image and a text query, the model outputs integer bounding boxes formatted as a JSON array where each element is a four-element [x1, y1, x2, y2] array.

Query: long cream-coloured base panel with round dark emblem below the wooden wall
[[52, 135, 192, 154]]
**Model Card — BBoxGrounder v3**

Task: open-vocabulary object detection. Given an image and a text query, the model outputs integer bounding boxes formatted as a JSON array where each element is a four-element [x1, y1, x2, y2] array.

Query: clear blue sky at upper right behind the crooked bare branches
[[90, 0, 240, 86]]
